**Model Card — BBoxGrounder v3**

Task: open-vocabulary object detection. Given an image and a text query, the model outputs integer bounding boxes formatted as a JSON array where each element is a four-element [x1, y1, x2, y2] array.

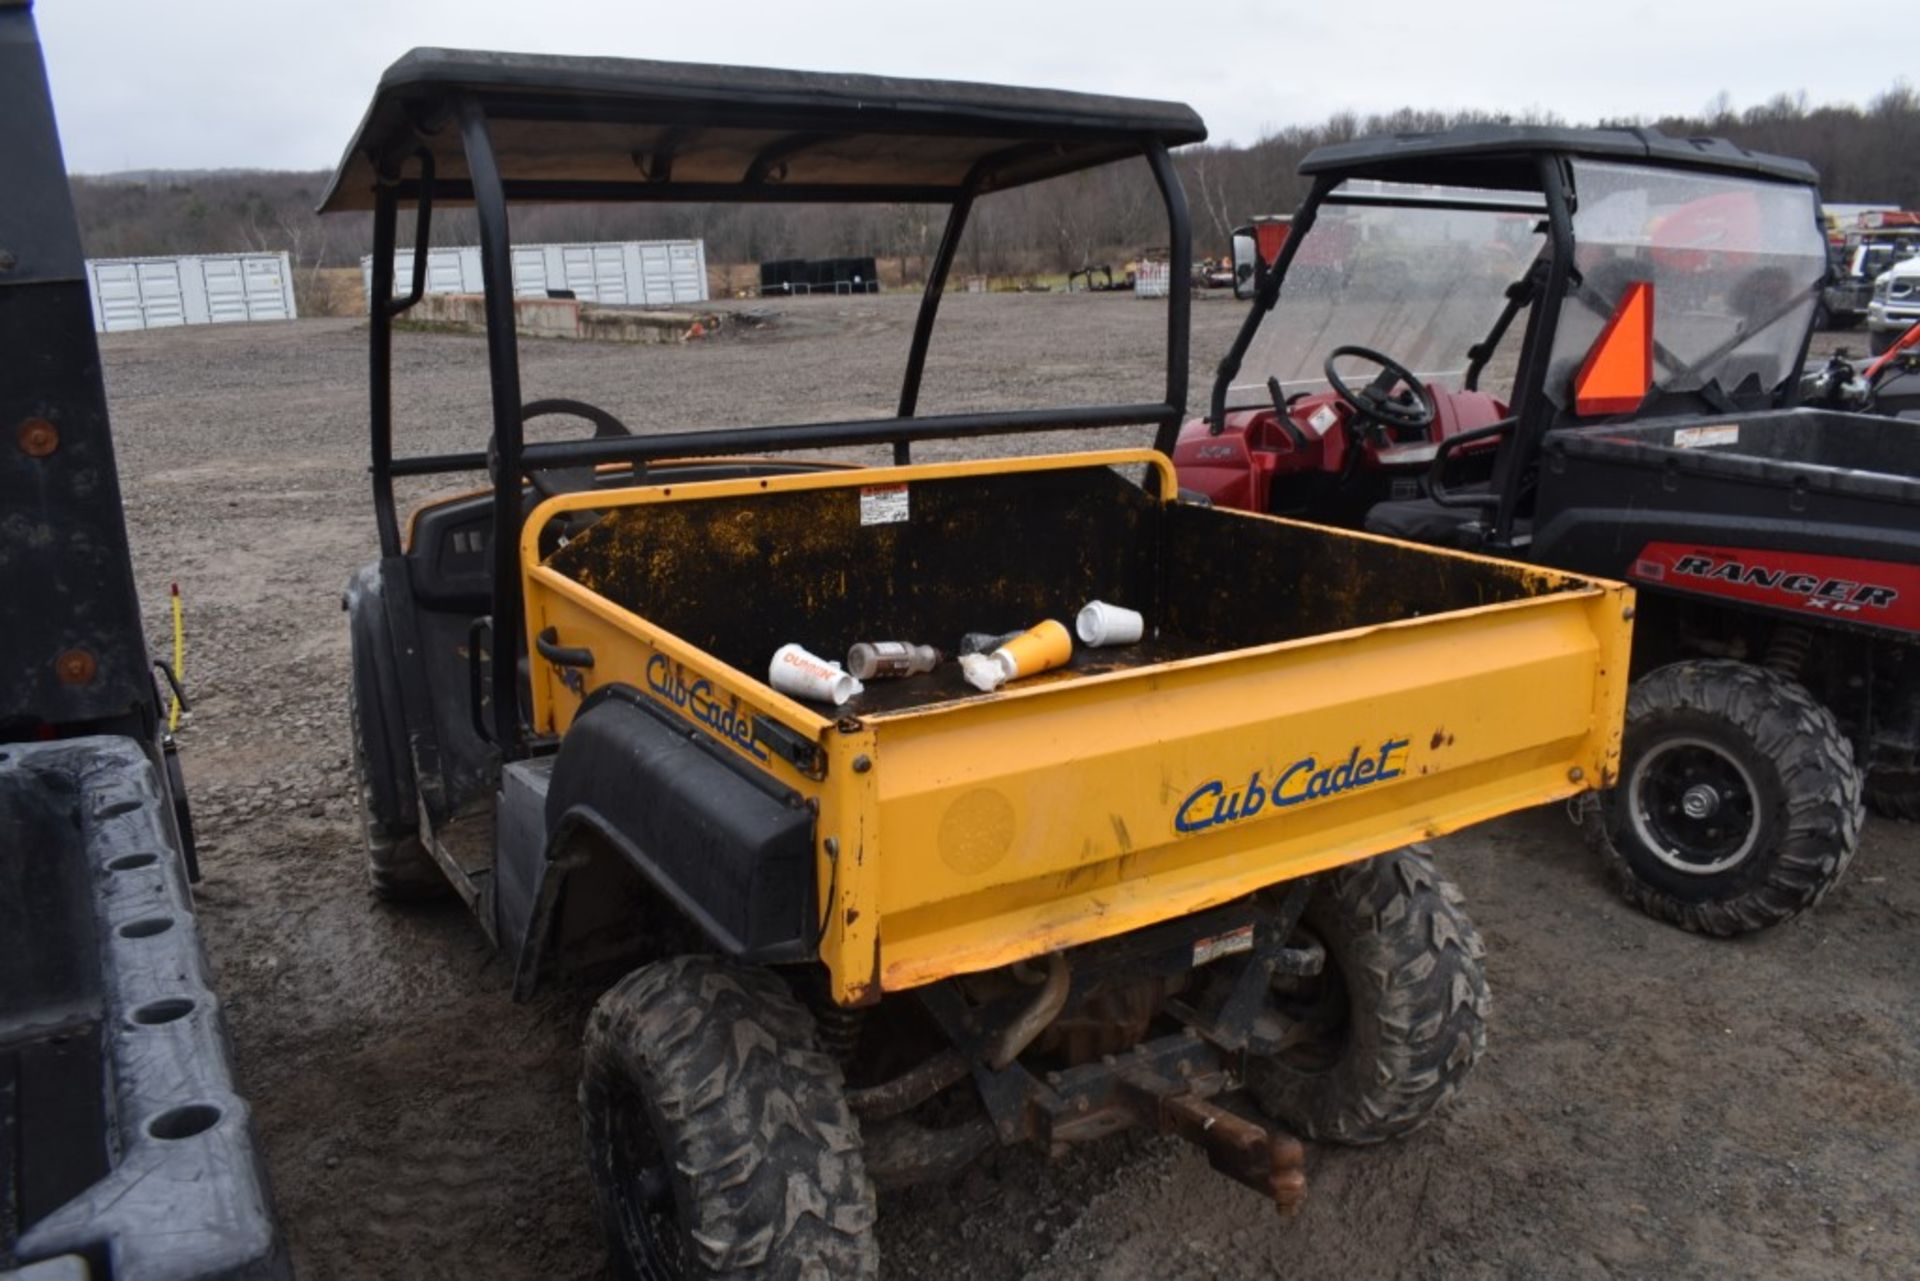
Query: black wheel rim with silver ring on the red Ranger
[[1626, 737, 1761, 876]]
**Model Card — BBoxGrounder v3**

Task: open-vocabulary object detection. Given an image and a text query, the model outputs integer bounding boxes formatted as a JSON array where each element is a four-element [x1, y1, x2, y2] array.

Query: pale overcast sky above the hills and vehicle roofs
[[36, 0, 1920, 173]]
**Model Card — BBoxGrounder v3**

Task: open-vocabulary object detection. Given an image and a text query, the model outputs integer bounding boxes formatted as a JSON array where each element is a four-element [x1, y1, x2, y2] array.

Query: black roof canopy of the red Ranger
[[1300, 125, 1820, 190]]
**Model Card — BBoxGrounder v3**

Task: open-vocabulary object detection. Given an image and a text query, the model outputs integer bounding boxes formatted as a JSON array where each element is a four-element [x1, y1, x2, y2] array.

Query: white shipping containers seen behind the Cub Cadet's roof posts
[[361, 240, 707, 307]]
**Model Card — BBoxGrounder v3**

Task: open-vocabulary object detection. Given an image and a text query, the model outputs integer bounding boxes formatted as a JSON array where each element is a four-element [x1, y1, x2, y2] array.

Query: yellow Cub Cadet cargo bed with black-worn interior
[[522, 449, 1632, 1003]]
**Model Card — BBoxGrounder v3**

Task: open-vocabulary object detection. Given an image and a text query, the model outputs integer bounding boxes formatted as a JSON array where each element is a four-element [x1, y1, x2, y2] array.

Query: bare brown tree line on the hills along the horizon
[[73, 83, 1920, 288]]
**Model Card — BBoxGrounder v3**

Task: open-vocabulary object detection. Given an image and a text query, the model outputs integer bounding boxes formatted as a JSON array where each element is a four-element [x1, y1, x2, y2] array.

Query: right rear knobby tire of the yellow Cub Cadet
[[1246, 847, 1490, 1145]]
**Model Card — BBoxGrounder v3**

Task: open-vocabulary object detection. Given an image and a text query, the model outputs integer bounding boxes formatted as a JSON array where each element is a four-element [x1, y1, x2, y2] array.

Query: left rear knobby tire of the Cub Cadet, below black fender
[[580, 956, 879, 1281]]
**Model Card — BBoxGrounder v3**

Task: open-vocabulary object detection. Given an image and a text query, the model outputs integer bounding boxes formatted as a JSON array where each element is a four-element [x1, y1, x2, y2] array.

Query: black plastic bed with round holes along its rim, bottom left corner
[[0, 737, 288, 1277]]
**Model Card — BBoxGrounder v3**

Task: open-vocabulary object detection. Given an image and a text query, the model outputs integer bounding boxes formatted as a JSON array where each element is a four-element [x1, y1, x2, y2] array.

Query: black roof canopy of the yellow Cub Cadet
[[321, 48, 1206, 213]]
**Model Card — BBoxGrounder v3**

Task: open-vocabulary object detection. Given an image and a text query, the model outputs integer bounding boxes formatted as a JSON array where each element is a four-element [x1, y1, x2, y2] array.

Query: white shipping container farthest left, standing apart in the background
[[86, 254, 296, 334]]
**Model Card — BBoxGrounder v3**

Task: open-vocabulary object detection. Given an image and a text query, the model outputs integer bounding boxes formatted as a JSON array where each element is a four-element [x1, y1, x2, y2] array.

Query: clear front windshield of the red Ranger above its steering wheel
[[1227, 181, 1546, 405]]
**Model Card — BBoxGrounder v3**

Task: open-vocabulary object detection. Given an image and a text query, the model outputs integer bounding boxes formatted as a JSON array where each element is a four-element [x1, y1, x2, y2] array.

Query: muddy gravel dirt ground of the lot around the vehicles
[[104, 296, 1920, 1281]]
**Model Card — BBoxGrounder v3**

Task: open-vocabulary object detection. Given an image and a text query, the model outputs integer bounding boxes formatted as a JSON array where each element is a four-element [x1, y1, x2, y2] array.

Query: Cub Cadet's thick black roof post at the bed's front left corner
[[459, 98, 526, 761]]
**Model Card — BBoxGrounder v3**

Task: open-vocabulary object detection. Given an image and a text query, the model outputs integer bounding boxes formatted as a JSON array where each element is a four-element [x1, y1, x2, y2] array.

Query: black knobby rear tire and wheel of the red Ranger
[[1586, 659, 1864, 937]]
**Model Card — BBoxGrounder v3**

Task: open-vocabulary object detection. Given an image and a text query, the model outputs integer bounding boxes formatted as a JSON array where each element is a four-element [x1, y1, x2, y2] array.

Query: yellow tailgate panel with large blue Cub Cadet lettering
[[876, 592, 1626, 987]]
